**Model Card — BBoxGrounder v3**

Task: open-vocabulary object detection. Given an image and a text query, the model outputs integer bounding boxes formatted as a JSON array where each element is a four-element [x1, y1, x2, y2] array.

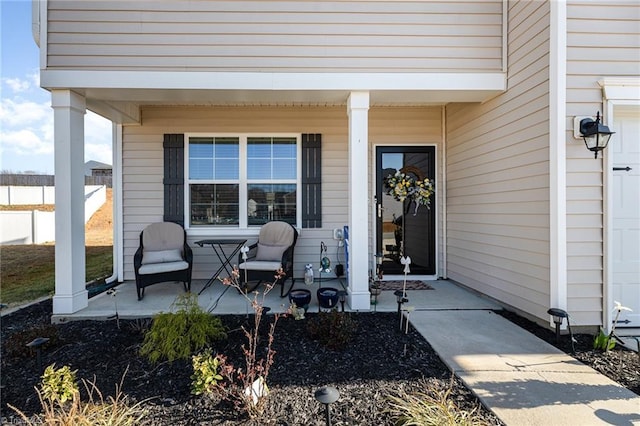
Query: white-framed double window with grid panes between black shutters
[[185, 134, 301, 228]]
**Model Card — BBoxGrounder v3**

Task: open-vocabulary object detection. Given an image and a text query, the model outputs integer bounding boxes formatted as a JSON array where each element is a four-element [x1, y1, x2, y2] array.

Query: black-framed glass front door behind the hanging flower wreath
[[375, 146, 436, 275]]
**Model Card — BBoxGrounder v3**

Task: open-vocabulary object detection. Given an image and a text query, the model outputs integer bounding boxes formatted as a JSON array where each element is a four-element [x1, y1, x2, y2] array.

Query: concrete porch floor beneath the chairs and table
[[53, 279, 500, 322]]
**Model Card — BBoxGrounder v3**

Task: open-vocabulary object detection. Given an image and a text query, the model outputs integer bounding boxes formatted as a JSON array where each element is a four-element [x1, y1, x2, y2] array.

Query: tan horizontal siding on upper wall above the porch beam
[[47, 0, 502, 72]]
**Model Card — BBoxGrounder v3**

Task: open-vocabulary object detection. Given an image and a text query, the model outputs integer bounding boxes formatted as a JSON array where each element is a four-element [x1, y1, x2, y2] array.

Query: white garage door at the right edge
[[609, 106, 640, 331]]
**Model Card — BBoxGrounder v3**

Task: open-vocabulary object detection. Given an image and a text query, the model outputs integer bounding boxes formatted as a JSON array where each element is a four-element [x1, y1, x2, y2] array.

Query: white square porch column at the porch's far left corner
[[51, 90, 89, 315]]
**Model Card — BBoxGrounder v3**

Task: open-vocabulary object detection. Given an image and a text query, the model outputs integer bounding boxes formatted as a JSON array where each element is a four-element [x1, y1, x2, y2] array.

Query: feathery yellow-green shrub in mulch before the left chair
[[140, 293, 227, 363]]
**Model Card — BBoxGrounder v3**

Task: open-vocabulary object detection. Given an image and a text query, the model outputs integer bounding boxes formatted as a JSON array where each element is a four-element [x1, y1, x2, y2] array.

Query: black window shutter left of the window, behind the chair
[[162, 134, 184, 226]]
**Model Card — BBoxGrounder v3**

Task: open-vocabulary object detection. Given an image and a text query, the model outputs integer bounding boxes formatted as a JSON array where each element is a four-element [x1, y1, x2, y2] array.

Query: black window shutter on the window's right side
[[302, 133, 322, 228]]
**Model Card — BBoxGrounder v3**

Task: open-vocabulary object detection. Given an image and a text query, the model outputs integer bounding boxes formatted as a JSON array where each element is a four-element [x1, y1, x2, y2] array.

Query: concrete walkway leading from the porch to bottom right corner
[[410, 310, 640, 426]]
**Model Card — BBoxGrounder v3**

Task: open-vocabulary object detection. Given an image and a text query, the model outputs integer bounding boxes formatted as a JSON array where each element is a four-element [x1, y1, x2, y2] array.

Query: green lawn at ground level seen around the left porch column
[[0, 245, 113, 306]]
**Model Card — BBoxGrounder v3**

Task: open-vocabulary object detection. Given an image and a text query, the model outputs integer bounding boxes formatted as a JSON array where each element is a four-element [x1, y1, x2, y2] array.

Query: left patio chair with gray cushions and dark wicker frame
[[133, 222, 193, 300]]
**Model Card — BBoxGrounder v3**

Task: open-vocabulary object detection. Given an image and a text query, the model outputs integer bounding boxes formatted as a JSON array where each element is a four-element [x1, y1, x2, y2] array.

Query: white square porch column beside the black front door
[[347, 92, 371, 310]]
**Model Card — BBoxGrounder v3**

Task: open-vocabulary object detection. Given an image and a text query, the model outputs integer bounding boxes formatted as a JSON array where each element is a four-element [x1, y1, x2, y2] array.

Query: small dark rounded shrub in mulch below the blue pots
[[307, 309, 357, 349]]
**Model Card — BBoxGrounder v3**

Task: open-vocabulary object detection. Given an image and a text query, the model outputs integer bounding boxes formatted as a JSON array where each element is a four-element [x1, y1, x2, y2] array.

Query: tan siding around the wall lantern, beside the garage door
[[567, 0, 640, 325]]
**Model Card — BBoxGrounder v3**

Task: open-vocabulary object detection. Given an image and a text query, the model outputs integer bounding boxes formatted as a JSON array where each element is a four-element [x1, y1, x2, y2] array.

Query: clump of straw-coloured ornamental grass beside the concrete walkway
[[389, 381, 487, 426]]
